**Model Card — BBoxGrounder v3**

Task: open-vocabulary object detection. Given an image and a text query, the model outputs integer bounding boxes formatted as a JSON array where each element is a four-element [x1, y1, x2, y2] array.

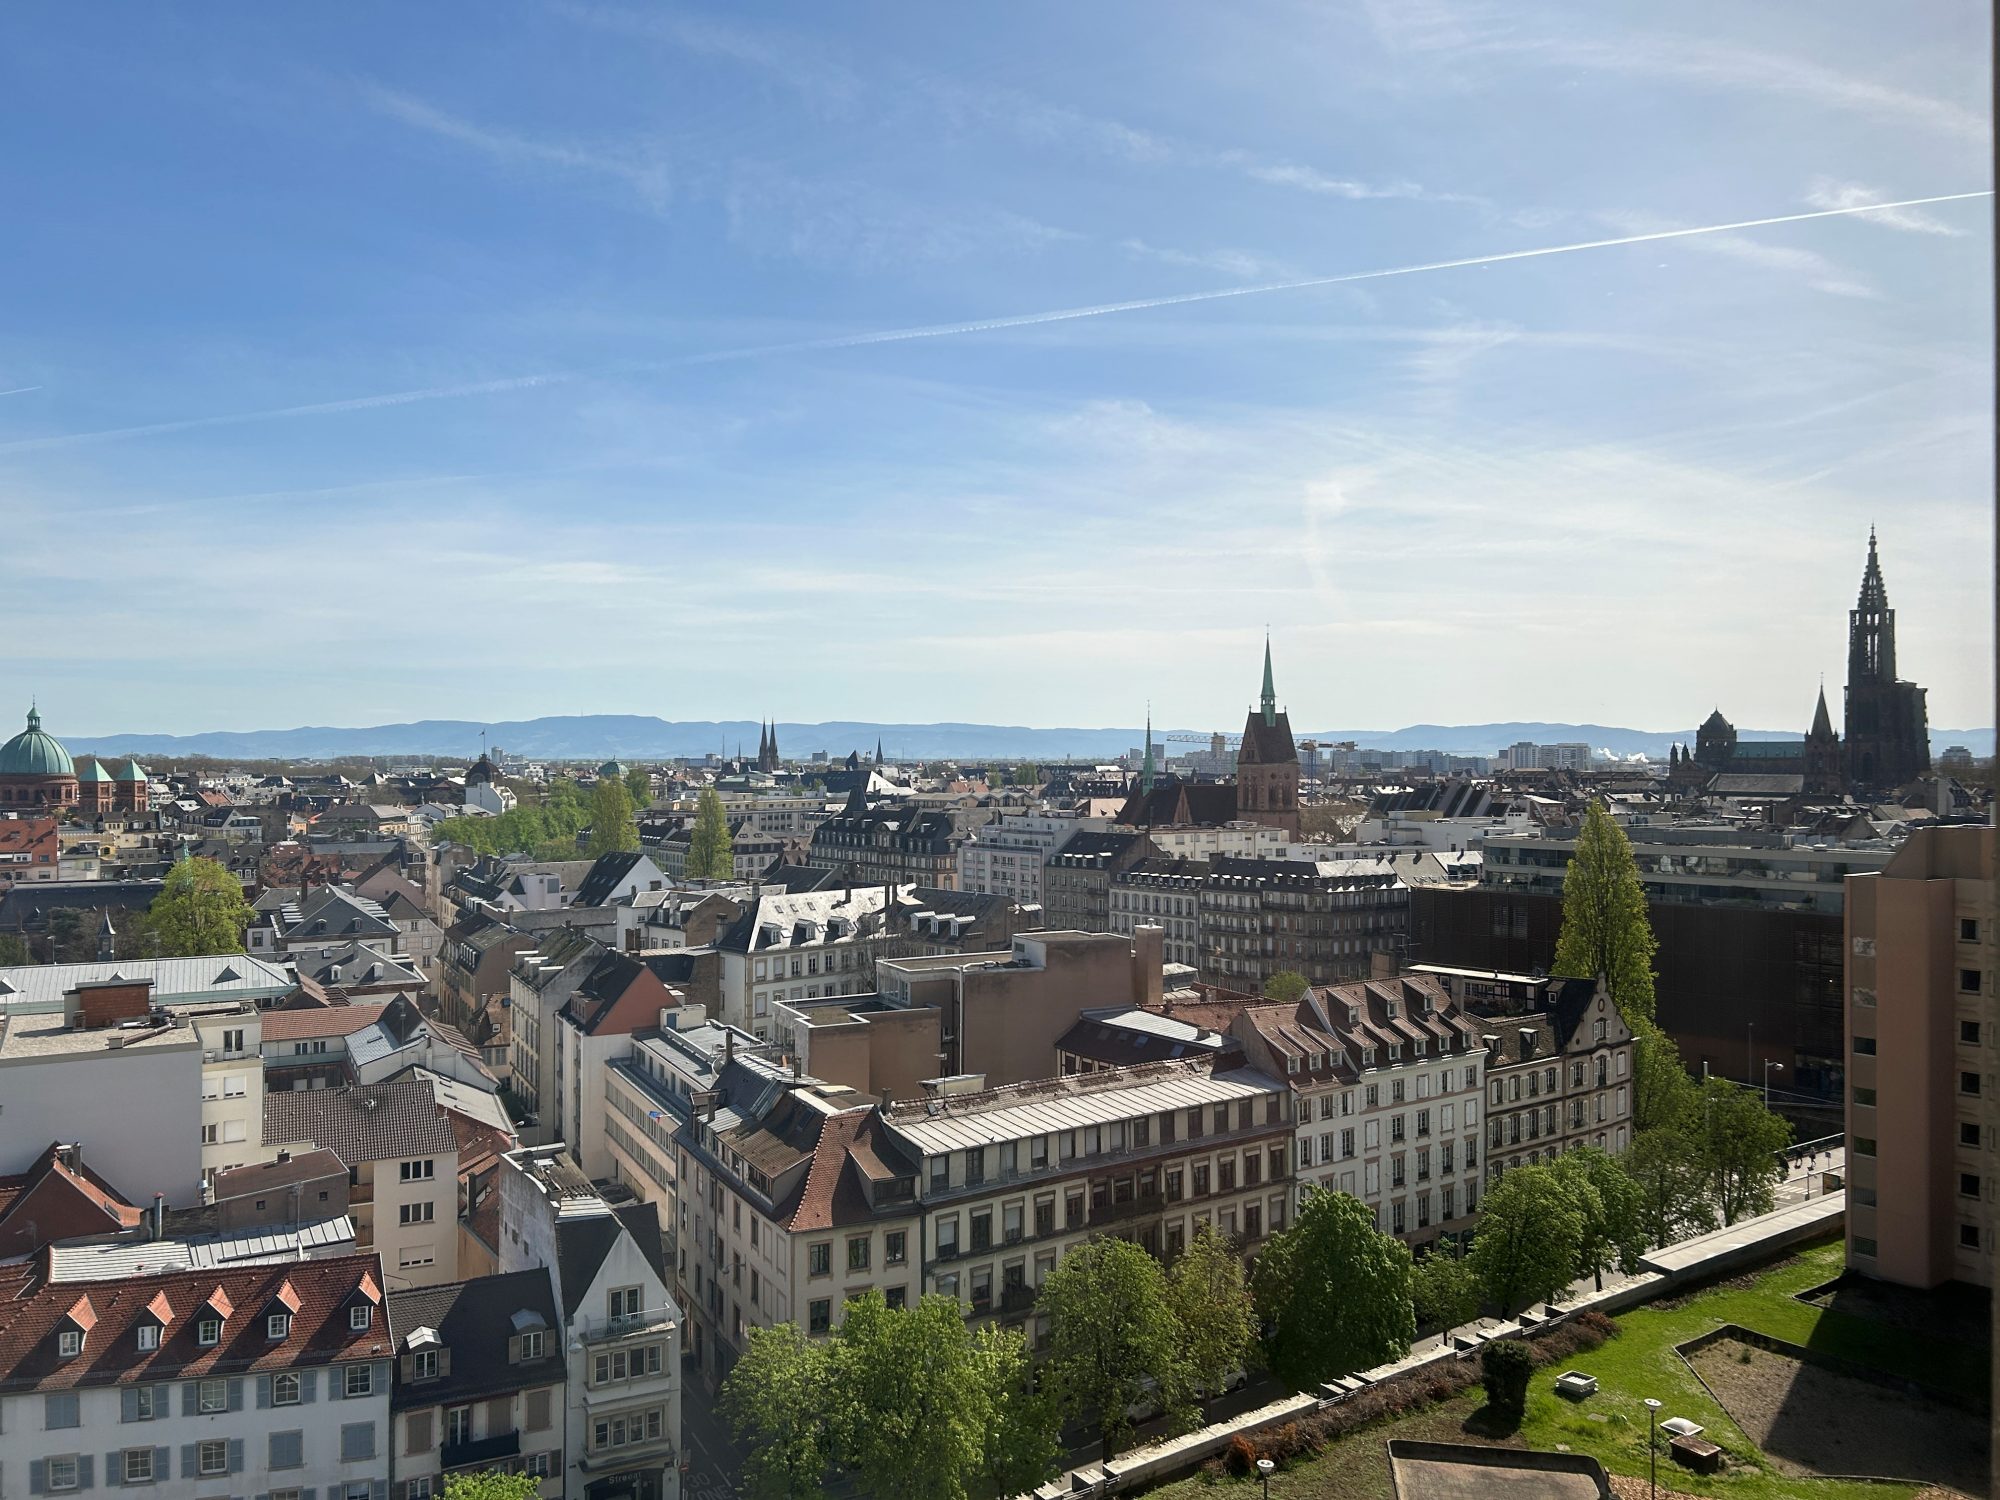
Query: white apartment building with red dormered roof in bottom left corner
[[0, 1254, 390, 1500]]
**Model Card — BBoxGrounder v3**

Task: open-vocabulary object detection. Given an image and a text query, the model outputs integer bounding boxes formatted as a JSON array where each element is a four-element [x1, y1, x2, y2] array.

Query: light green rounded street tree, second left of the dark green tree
[[1040, 1240, 1192, 1458]]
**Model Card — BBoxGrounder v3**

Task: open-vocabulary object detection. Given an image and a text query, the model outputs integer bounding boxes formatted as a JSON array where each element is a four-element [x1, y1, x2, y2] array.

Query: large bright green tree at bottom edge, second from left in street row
[[826, 1292, 990, 1500]]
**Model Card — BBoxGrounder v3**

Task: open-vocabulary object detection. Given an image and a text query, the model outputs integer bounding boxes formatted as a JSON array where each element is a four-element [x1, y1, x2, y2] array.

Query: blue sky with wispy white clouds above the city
[[0, 0, 1994, 734]]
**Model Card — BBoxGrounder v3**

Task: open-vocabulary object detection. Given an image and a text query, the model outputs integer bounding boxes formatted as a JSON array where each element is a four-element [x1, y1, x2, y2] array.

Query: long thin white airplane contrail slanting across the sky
[[0, 188, 1992, 454]]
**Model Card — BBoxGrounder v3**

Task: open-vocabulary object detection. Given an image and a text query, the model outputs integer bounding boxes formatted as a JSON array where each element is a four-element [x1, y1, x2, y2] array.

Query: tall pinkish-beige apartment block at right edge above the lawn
[[1844, 824, 2000, 1288]]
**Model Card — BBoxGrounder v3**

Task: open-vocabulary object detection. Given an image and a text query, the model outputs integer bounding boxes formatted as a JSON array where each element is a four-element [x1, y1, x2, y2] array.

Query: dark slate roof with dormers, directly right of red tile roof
[[388, 1268, 568, 1412]]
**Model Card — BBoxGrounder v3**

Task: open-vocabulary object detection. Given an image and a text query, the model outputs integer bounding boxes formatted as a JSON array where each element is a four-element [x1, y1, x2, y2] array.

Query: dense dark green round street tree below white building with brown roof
[[1250, 1188, 1416, 1390]]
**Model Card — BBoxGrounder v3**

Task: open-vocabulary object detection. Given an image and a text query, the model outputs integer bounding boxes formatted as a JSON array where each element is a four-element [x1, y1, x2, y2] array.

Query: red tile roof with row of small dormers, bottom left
[[0, 1252, 390, 1392]]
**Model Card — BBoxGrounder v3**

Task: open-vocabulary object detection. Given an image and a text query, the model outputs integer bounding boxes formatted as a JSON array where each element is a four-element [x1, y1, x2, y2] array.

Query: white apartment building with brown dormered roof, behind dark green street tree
[[1198, 976, 1486, 1250]]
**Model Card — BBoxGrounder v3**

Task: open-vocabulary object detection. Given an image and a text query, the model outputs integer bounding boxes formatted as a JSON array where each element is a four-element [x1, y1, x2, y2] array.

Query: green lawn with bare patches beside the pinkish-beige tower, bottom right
[[1156, 1244, 1986, 1500]]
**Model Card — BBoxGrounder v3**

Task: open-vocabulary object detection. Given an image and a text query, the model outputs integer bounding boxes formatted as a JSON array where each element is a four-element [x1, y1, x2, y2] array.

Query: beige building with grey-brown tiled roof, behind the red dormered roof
[[264, 1078, 458, 1288]]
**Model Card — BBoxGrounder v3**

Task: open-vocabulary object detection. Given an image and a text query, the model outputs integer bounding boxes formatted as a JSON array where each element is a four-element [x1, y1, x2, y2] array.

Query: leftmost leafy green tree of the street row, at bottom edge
[[720, 1322, 832, 1500]]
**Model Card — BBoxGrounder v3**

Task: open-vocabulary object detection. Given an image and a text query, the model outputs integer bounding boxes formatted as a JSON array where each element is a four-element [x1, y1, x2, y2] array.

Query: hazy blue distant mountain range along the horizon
[[66, 714, 1994, 760]]
